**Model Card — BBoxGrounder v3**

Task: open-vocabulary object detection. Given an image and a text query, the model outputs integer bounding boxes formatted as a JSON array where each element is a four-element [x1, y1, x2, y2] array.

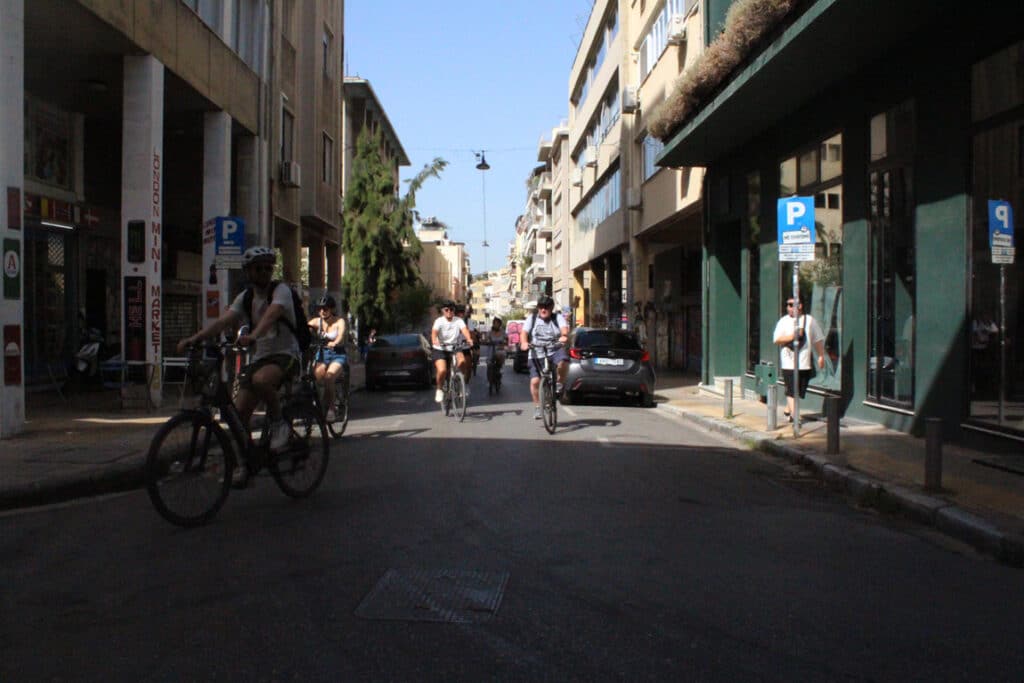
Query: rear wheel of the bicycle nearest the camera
[[270, 401, 331, 498]]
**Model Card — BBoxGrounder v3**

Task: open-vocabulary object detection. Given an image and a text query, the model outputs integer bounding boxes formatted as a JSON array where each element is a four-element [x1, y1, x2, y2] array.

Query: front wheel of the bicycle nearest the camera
[[145, 411, 234, 526]]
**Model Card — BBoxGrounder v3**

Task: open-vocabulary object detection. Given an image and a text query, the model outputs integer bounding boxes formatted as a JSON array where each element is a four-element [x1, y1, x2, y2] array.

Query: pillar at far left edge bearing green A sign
[[0, 0, 25, 438]]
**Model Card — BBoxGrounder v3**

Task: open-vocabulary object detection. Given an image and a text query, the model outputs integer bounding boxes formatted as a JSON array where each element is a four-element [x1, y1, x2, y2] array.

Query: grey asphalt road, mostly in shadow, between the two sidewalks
[[0, 372, 1024, 683]]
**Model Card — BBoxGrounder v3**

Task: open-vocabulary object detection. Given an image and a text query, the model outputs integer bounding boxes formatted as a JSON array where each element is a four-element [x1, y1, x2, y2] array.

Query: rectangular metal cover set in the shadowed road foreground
[[355, 569, 509, 624]]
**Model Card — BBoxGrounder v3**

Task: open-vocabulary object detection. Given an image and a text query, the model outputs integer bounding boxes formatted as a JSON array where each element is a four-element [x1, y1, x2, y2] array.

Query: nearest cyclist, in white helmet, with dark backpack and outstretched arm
[[178, 247, 299, 454]]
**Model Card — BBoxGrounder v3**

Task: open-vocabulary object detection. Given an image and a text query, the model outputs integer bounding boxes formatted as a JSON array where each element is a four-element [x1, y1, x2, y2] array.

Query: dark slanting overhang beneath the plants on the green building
[[654, 0, 962, 167]]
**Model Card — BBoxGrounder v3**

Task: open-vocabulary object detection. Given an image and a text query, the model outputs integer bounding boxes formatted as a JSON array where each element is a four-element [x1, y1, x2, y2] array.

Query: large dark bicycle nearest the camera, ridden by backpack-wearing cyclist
[[145, 342, 330, 527]]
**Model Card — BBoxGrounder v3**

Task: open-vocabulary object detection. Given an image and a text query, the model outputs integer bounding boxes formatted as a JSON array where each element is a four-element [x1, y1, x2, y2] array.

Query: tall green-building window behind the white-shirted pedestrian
[[778, 133, 843, 392]]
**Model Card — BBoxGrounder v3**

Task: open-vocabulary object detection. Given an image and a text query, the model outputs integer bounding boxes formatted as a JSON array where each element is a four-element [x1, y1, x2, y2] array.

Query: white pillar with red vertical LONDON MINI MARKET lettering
[[121, 55, 164, 408]]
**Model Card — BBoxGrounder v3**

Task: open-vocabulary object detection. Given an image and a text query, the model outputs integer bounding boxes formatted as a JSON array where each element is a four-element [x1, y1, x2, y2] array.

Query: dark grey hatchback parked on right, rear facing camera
[[562, 328, 656, 407]]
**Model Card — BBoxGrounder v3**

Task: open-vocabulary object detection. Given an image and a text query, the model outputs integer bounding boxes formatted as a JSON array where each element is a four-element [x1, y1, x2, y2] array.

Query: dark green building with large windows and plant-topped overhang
[[657, 0, 1024, 442]]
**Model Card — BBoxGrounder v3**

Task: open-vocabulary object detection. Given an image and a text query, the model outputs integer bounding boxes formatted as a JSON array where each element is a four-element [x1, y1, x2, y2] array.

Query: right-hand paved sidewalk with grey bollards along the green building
[[657, 374, 1024, 566]]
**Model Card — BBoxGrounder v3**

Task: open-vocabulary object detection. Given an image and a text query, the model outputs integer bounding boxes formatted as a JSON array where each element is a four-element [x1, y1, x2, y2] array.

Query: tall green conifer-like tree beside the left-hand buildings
[[342, 128, 447, 329]]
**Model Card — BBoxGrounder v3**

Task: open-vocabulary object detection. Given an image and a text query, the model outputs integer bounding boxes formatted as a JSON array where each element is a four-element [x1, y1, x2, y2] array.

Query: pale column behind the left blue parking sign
[[200, 112, 231, 328]]
